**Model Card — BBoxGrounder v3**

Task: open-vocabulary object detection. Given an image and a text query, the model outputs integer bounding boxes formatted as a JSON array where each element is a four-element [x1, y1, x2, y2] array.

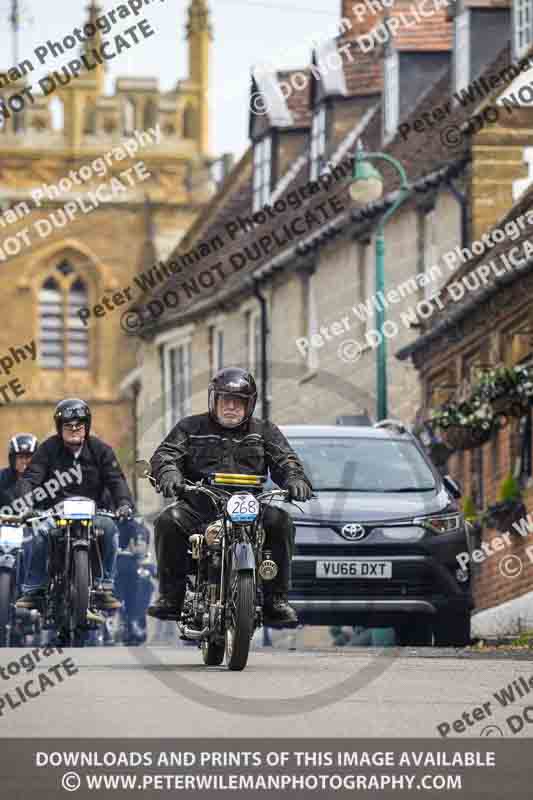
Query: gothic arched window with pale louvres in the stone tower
[[39, 261, 89, 369]]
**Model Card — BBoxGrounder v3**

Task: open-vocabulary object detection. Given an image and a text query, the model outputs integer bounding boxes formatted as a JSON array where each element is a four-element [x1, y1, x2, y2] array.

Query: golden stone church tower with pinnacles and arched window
[[0, 0, 214, 476]]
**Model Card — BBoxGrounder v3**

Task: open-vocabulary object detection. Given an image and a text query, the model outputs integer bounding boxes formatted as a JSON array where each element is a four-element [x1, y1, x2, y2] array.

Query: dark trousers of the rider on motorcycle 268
[[155, 501, 295, 602]]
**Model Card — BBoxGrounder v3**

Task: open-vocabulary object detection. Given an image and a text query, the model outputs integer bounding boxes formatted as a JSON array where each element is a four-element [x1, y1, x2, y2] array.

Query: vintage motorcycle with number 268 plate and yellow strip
[[137, 461, 302, 670]]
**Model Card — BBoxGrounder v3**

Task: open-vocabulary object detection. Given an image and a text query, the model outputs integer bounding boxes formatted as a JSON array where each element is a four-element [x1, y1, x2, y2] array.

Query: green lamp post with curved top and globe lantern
[[350, 149, 411, 420]]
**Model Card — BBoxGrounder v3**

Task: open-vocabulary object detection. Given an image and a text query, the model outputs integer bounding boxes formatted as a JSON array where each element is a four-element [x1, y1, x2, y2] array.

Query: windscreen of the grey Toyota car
[[290, 437, 436, 492]]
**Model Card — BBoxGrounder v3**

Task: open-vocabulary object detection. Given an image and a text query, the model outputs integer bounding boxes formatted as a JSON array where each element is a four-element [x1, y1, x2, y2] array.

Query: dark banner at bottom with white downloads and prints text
[[0, 738, 533, 800]]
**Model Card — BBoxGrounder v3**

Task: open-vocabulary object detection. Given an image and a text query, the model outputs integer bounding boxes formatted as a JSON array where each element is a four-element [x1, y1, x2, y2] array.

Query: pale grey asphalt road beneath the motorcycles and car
[[0, 646, 533, 738]]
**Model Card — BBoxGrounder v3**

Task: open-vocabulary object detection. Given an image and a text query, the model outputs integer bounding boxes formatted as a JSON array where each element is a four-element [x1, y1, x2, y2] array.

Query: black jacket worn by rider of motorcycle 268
[[150, 414, 311, 489]]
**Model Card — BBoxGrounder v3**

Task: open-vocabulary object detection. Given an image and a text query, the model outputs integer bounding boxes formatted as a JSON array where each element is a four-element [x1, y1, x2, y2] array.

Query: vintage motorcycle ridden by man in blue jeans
[[0, 497, 114, 647]]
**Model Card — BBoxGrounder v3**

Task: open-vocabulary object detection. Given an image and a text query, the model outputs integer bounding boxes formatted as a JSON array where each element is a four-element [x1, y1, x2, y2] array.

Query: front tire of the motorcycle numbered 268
[[226, 572, 255, 671]]
